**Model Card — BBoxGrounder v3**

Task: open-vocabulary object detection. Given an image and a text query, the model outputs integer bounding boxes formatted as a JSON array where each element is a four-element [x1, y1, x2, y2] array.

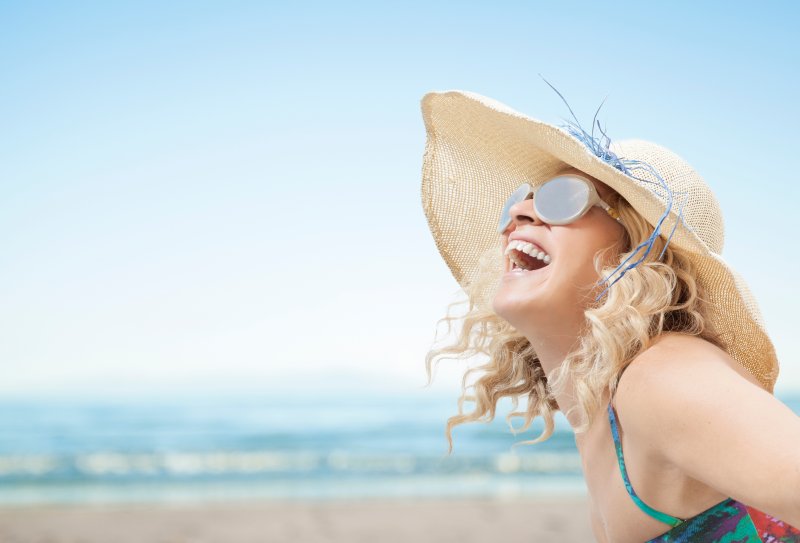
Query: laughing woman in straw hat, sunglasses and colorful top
[[422, 87, 800, 543]]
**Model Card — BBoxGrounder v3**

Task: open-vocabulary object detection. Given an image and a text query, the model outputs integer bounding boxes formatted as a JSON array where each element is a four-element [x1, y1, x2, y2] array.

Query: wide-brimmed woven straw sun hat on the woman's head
[[421, 90, 779, 393]]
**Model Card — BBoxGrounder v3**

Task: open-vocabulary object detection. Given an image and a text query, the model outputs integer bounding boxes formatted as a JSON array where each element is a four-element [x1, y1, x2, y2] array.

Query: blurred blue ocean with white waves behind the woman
[[0, 390, 800, 505]]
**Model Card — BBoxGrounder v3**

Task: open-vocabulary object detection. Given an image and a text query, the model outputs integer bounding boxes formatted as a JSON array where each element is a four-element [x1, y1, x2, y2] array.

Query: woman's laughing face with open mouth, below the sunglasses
[[492, 168, 624, 329]]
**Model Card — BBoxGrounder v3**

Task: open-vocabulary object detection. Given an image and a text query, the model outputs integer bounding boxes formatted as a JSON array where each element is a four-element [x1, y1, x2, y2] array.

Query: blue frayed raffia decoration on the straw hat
[[539, 74, 691, 301]]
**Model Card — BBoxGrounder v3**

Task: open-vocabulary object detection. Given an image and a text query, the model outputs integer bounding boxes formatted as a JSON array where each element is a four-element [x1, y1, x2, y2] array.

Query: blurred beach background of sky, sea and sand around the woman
[[0, 1, 800, 541]]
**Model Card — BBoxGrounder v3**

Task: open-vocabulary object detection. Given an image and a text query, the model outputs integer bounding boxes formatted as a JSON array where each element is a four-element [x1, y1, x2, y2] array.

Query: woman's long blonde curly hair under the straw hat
[[425, 182, 724, 455]]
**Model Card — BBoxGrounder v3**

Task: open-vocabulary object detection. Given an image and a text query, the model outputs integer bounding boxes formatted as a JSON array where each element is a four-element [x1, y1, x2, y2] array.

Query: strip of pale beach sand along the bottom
[[0, 497, 594, 543]]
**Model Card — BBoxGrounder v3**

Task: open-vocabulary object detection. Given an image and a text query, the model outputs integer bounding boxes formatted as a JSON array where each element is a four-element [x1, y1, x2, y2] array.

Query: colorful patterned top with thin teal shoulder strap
[[608, 402, 800, 543]]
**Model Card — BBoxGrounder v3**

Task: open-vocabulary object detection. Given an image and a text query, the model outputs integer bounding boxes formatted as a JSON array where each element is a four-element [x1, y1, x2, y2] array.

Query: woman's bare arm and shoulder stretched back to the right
[[615, 336, 800, 527]]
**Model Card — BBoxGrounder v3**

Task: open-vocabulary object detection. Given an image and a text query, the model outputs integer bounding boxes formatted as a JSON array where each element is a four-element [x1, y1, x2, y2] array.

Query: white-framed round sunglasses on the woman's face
[[497, 174, 622, 234]]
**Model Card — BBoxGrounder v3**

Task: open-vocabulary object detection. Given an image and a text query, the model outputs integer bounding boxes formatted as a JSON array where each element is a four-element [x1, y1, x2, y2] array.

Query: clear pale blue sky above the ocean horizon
[[0, 1, 800, 397]]
